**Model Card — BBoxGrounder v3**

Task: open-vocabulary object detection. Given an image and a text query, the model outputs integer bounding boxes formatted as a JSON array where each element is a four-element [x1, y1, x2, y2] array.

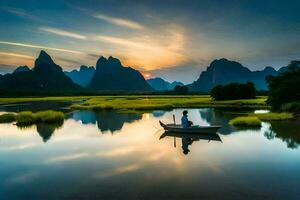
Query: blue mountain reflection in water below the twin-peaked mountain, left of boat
[[70, 110, 142, 133]]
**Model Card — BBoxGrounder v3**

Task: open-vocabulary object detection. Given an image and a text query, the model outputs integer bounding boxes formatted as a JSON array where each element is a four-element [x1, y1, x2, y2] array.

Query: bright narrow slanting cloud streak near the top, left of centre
[[94, 15, 144, 29]]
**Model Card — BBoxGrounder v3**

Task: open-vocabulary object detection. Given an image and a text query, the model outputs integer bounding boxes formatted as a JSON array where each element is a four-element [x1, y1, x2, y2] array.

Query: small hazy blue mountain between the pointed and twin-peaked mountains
[[65, 65, 95, 87]]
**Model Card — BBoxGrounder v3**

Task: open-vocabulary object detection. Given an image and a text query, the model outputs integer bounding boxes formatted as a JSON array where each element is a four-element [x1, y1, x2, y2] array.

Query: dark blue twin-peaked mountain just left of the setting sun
[[88, 56, 152, 92]]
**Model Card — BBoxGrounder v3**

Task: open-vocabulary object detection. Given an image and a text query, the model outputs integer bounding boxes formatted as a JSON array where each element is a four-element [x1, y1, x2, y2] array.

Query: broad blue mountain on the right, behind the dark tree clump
[[188, 58, 278, 92]]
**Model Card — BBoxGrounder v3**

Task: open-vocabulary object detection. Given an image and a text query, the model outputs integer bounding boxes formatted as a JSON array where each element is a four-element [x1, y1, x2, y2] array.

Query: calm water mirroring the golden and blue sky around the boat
[[0, 109, 300, 199]]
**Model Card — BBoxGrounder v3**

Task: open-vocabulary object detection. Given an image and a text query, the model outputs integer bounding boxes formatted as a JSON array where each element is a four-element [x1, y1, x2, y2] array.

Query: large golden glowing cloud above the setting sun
[[92, 28, 187, 70]]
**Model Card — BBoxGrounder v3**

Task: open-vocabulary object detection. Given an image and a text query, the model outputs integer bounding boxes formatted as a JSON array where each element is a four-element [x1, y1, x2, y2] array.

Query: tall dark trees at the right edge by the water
[[266, 60, 300, 109]]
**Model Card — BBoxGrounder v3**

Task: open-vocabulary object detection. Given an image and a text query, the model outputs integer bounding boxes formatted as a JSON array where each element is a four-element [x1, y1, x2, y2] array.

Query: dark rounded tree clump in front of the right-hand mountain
[[210, 82, 256, 100]]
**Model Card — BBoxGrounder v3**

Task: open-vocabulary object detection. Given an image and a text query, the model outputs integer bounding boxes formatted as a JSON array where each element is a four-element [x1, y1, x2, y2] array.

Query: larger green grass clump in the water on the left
[[16, 110, 65, 126]]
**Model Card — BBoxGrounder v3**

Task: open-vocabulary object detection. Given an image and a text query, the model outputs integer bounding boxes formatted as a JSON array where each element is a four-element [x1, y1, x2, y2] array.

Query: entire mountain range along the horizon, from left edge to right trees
[[0, 50, 286, 94]]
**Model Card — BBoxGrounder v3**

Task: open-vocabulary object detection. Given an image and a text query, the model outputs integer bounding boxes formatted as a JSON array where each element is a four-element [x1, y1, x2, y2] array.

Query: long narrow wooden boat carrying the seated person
[[159, 121, 221, 134]]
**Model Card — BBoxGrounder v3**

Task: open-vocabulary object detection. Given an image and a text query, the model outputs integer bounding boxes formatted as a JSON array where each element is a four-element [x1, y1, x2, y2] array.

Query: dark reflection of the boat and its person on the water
[[159, 131, 222, 155]]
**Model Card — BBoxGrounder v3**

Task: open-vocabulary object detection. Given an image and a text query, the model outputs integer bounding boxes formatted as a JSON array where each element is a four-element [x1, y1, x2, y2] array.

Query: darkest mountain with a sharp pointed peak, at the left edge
[[0, 50, 81, 93]]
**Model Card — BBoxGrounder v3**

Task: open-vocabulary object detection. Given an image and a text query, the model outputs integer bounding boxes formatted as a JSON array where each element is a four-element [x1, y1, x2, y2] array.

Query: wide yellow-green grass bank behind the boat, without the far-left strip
[[70, 95, 268, 111]]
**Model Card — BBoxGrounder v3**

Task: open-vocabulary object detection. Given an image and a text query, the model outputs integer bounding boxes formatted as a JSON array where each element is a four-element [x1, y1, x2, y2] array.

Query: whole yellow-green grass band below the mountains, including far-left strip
[[0, 95, 269, 111]]
